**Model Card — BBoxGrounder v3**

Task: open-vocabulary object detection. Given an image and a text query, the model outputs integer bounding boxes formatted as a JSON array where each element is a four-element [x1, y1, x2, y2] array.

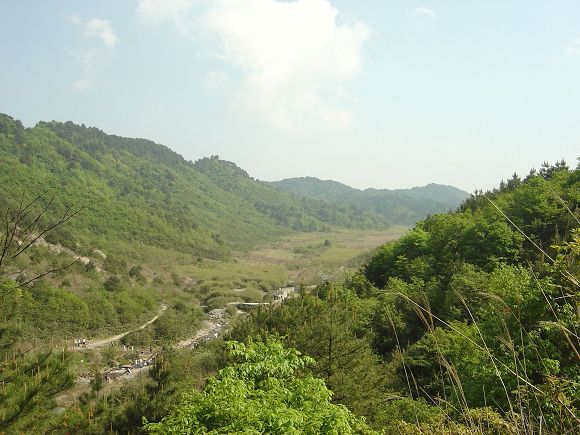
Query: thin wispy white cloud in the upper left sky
[[64, 14, 117, 93]]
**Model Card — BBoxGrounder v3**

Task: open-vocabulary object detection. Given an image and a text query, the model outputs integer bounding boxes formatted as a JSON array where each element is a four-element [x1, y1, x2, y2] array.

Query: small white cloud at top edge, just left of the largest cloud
[[137, 0, 193, 35]]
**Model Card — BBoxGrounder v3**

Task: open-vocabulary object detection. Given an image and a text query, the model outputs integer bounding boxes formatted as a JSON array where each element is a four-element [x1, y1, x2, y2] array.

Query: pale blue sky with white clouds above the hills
[[0, 0, 580, 192]]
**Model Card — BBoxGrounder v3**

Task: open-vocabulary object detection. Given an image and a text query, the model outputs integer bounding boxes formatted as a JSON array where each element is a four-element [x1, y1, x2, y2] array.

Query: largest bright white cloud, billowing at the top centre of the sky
[[198, 0, 370, 129]]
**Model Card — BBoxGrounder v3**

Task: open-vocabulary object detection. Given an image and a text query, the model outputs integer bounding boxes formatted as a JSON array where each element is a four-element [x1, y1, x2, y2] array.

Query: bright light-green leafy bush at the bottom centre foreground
[[145, 340, 372, 434]]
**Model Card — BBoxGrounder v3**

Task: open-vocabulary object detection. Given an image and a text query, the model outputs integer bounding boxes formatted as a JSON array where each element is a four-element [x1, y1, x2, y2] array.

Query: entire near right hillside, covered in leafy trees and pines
[[220, 162, 580, 435]]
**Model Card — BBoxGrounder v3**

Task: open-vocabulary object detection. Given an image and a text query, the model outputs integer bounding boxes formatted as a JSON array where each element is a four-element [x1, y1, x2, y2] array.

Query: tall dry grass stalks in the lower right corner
[[380, 192, 580, 434]]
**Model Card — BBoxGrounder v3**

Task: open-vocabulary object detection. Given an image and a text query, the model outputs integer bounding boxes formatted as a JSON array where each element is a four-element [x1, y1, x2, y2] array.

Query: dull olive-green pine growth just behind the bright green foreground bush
[[230, 283, 384, 428]]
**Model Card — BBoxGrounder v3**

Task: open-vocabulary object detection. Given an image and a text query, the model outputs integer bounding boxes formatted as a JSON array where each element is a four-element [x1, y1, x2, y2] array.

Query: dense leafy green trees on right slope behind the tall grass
[[364, 164, 580, 433]]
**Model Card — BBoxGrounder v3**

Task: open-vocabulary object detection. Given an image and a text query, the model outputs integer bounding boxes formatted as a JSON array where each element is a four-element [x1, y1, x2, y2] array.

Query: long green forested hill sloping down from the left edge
[[0, 114, 390, 257]]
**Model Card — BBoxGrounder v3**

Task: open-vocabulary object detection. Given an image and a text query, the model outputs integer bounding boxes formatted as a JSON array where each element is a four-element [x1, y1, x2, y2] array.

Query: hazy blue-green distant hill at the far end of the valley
[[269, 177, 469, 225]]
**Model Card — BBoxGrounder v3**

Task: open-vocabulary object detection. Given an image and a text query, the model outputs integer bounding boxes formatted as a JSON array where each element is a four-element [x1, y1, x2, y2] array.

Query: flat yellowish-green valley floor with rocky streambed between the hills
[[49, 226, 408, 414]]
